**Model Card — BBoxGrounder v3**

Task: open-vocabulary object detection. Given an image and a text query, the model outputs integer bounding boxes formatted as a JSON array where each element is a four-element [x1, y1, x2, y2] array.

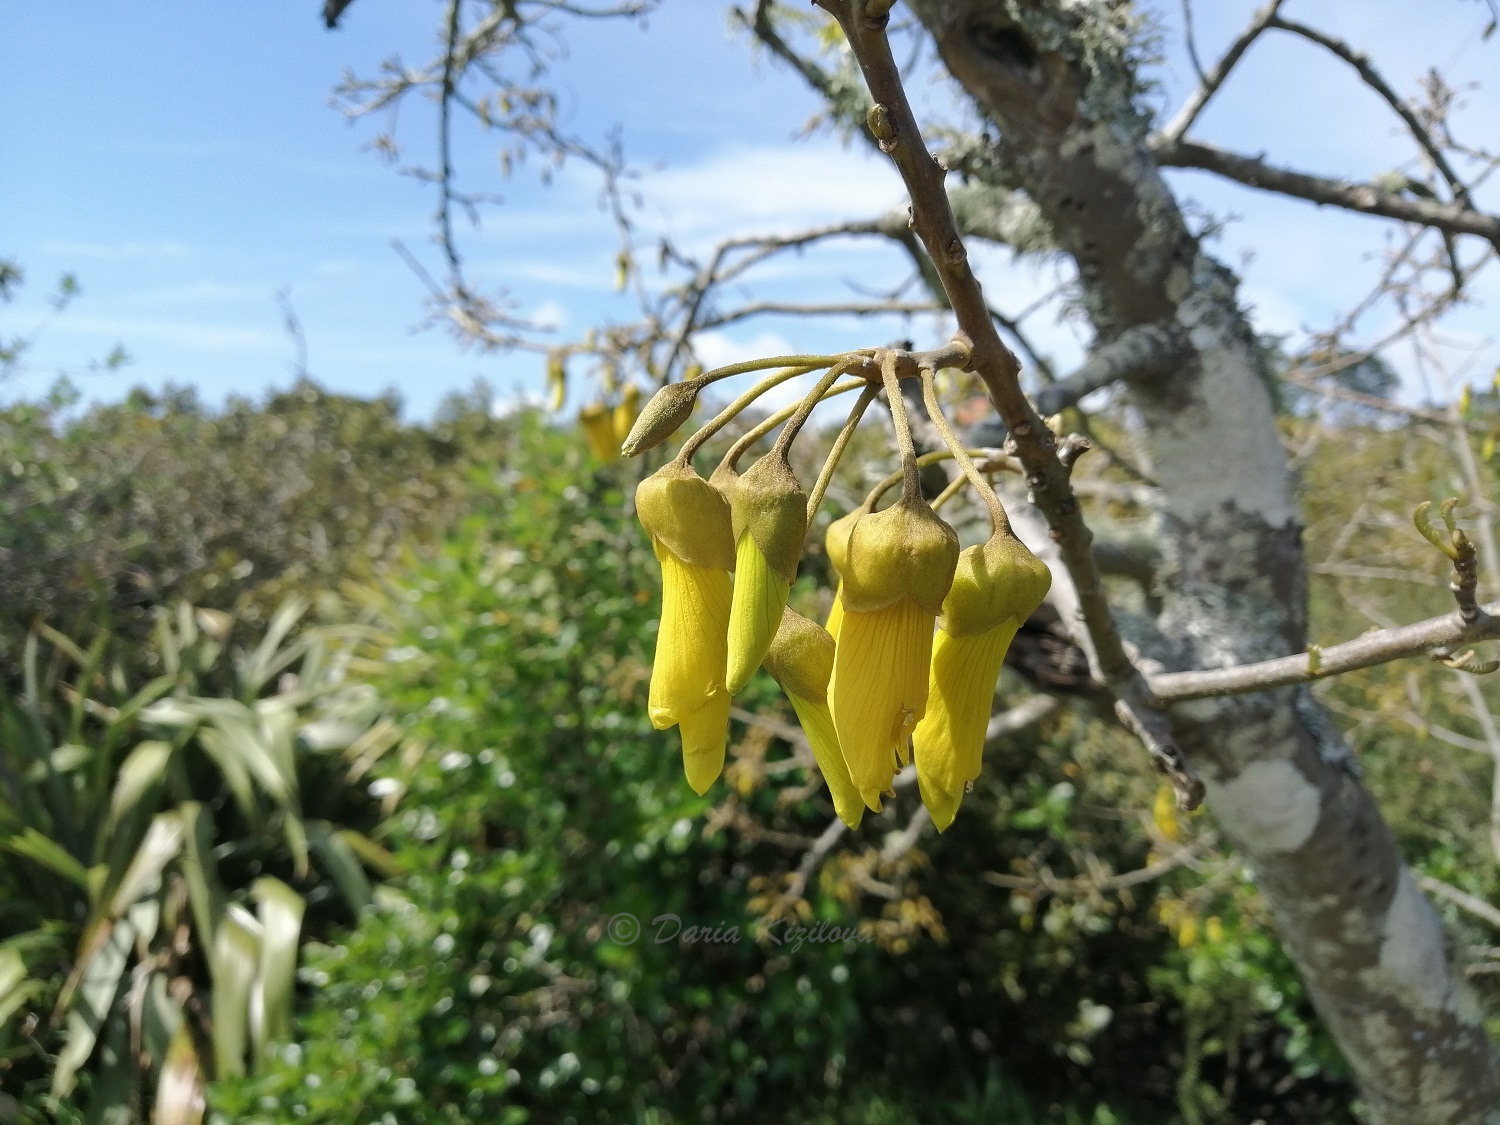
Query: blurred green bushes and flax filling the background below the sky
[[0, 348, 1500, 1125]]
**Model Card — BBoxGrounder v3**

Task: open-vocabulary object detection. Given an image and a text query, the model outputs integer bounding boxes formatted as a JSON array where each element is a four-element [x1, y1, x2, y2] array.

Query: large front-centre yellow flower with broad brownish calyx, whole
[[830, 495, 959, 812]]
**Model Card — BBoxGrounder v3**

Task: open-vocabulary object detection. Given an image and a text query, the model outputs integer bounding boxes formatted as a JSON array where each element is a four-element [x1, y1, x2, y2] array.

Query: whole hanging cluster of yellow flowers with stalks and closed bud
[[624, 351, 1052, 828]]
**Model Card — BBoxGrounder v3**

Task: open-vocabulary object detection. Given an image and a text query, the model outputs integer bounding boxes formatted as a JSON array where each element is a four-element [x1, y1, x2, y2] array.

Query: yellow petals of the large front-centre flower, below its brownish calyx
[[828, 599, 936, 812]]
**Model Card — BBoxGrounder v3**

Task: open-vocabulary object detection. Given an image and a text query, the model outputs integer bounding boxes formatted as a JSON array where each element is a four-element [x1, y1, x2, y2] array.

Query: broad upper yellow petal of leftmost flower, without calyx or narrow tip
[[648, 540, 731, 731]]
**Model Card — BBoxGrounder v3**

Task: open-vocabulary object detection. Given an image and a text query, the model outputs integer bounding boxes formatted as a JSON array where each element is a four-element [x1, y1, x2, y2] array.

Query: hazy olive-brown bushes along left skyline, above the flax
[[0, 383, 506, 666]]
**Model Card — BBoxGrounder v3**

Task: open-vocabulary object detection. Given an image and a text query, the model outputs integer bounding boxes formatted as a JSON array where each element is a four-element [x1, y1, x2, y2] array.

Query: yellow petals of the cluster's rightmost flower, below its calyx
[[912, 618, 1020, 830]]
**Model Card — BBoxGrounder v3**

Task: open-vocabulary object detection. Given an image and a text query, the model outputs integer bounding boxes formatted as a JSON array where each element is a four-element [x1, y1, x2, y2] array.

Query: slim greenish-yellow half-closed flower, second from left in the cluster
[[726, 453, 807, 695]]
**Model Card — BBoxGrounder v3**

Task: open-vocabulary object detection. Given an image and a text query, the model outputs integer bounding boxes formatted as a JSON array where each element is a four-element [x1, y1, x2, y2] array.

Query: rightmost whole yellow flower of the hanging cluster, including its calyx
[[912, 528, 1052, 831]]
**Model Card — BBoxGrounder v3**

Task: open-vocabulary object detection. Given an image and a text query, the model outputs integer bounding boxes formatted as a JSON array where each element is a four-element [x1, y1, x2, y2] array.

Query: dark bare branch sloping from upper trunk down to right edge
[[1154, 141, 1500, 251]]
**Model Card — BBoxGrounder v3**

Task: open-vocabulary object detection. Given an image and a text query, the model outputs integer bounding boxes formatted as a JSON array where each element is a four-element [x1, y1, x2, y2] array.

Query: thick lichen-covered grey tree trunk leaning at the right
[[912, 0, 1500, 1125]]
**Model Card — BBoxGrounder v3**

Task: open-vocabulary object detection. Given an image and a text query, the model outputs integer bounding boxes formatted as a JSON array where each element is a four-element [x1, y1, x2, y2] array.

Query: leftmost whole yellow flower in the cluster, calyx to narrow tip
[[636, 461, 735, 794]]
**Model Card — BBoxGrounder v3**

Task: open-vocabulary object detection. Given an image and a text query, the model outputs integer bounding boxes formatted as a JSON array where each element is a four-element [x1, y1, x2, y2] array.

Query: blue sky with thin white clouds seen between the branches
[[0, 0, 1500, 417]]
